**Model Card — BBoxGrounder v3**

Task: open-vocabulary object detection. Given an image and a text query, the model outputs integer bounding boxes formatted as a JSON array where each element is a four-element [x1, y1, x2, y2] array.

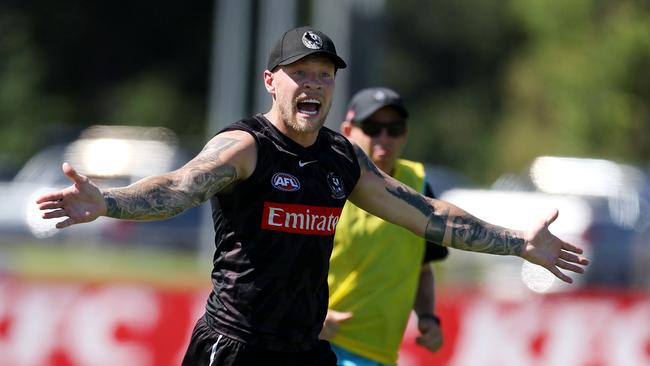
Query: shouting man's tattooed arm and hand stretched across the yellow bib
[[350, 146, 588, 282]]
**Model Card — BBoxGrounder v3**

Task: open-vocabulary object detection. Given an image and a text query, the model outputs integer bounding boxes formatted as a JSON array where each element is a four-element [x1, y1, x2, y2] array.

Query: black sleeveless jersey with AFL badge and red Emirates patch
[[206, 114, 360, 351]]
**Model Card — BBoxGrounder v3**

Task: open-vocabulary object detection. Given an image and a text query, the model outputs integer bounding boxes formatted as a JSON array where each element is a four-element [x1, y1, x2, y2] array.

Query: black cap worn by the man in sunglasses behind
[[345, 87, 409, 123]]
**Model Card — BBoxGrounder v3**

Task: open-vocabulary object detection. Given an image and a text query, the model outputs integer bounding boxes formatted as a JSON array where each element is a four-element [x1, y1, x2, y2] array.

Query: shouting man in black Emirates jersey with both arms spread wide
[[37, 27, 587, 365]]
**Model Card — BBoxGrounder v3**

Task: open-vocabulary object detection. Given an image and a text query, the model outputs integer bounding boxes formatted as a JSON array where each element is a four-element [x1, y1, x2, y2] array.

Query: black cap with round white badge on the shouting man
[[266, 27, 347, 70]]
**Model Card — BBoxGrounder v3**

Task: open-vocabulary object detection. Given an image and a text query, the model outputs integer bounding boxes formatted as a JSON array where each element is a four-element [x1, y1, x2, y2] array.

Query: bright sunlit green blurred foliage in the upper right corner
[[494, 0, 650, 174]]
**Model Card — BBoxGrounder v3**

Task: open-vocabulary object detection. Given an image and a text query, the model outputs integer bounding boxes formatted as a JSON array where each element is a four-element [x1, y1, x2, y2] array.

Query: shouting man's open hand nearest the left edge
[[36, 163, 106, 229]]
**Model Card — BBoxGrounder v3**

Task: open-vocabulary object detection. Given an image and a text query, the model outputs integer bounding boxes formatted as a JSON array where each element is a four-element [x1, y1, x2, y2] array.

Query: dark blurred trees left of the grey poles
[[0, 0, 213, 176]]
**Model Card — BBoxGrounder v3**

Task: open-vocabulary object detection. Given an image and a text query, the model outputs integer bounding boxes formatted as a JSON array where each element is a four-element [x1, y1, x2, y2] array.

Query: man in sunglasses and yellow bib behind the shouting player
[[321, 87, 448, 366]]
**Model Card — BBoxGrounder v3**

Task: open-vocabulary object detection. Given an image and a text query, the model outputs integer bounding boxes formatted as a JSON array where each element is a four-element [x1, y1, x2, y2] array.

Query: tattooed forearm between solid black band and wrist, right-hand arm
[[451, 216, 525, 255]]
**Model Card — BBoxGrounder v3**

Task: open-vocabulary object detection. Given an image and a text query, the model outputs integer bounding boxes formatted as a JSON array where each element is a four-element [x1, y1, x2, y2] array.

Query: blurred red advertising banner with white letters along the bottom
[[0, 278, 650, 366]]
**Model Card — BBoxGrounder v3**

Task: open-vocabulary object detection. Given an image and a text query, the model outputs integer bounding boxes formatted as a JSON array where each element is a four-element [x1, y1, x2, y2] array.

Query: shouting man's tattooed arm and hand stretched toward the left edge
[[37, 131, 256, 228]]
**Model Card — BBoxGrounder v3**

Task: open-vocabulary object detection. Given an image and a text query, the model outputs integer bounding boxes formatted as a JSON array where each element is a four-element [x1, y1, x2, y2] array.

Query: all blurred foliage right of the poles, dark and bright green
[[373, 0, 650, 184]]
